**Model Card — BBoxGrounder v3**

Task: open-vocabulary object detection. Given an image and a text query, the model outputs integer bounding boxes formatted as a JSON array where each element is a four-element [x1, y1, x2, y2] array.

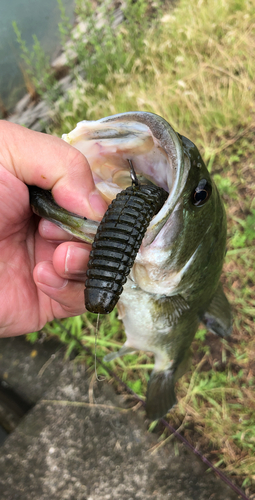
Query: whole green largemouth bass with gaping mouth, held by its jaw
[[28, 112, 232, 419]]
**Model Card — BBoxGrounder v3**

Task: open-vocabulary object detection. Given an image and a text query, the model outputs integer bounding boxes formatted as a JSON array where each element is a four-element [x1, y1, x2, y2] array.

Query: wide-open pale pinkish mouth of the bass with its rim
[[62, 112, 189, 246]]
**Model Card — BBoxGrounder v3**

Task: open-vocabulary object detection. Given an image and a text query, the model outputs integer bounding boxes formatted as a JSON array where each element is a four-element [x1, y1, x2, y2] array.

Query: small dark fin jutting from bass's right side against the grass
[[201, 283, 232, 337]]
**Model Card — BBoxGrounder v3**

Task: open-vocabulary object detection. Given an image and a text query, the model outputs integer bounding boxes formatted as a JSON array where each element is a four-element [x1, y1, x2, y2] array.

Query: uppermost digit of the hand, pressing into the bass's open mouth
[[0, 120, 107, 219]]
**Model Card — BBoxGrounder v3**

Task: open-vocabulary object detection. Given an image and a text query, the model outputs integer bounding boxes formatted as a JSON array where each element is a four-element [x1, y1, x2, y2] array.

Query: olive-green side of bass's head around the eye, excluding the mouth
[[160, 134, 227, 310]]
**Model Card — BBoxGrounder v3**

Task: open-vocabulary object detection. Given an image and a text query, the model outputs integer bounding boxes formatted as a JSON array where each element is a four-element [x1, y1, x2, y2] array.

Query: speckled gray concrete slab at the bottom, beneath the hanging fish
[[0, 363, 237, 500]]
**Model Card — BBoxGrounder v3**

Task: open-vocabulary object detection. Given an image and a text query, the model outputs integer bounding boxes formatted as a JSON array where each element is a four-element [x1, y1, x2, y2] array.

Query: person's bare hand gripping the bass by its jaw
[[0, 120, 107, 337]]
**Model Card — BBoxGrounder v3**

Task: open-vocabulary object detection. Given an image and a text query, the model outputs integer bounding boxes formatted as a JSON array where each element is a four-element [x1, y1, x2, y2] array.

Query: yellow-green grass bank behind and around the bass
[[24, 0, 255, 495]]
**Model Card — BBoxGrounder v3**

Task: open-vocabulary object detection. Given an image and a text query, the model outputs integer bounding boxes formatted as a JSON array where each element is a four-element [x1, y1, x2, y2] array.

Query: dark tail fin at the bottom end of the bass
[[146, 370, 176, 420]]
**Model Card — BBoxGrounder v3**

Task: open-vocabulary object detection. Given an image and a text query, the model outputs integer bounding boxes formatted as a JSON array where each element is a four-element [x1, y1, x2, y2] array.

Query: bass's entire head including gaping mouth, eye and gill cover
[[63, 112, 226, 303]]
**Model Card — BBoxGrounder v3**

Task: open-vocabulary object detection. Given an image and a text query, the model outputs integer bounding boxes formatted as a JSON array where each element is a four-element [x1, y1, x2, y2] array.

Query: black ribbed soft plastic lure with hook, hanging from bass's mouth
[[85, 169, 168, 314]]
